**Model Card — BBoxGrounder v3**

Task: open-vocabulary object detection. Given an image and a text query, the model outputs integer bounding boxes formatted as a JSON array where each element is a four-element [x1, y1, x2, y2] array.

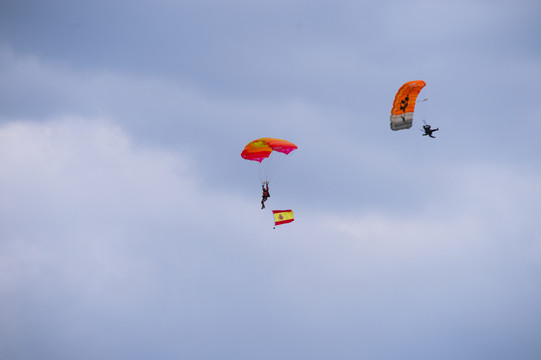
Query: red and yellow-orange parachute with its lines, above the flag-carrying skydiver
[[240, 138, 297, 183]]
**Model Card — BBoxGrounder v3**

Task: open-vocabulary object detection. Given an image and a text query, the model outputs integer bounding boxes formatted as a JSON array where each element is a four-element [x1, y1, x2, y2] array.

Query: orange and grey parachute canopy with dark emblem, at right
[[391, 80, 426, 130]]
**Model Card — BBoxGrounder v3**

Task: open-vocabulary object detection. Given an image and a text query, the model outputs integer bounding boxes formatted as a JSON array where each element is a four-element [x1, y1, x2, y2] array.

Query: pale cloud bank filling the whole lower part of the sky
[[0, 119, 541, 359]]
